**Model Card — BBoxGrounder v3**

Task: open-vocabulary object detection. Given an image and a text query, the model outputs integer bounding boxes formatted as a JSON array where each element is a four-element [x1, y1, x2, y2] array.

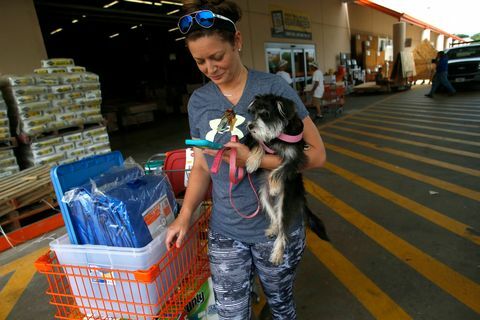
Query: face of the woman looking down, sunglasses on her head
[[187, 33, 242, 85]]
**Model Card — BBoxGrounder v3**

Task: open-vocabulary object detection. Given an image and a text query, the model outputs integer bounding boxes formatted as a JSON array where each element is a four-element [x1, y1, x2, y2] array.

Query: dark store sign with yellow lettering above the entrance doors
[[270, 5, 312, 40]]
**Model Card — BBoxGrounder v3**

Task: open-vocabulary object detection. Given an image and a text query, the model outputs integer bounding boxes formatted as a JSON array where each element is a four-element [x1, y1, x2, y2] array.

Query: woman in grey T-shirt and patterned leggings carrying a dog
[[166, 0, 325, 320]]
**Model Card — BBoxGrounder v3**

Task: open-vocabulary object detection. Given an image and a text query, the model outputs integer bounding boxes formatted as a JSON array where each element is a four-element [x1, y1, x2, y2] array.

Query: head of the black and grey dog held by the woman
[[247, 94, 296, 142]]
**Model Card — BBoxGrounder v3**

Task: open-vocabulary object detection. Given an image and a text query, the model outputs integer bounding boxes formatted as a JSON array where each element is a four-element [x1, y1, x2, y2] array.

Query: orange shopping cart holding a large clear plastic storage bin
[[35, 152, 211, 320]]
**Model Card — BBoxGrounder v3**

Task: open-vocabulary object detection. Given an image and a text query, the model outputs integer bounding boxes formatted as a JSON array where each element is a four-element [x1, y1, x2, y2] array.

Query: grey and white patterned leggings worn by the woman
[[208, 227, 305, 320]]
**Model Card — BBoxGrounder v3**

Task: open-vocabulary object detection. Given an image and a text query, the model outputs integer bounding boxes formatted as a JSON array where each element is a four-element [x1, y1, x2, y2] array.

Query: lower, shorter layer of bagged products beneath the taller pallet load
[[21, 126, 110, 167]]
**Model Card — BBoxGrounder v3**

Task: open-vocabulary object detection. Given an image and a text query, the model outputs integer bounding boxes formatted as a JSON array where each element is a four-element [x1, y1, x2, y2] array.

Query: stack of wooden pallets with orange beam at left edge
[[0, 165, 63, 252]]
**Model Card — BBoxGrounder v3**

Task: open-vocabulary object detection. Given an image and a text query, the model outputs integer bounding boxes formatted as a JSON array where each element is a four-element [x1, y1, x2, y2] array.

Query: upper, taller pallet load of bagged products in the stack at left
[[3, 59, 103, 136]]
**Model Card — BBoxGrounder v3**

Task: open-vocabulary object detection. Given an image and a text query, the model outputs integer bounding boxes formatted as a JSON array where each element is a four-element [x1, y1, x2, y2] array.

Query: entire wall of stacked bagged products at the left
[[0, 58, 110, 176]]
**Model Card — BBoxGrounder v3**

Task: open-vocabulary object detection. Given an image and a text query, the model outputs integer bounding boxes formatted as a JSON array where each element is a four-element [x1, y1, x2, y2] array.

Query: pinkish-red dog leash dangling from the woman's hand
[[211, 135, 260, 219]]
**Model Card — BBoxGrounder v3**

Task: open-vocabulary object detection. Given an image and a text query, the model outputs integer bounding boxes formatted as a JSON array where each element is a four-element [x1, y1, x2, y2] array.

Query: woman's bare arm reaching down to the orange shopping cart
[[165, 148, 210, 250]]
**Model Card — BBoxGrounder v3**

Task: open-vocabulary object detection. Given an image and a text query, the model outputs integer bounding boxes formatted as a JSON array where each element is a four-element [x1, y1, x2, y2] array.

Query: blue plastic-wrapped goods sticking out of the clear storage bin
[[62, 162, 177, 248]]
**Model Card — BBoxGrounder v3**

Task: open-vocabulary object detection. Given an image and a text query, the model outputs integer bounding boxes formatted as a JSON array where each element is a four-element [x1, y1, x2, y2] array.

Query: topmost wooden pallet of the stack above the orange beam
[[0, 165, 54, 218]]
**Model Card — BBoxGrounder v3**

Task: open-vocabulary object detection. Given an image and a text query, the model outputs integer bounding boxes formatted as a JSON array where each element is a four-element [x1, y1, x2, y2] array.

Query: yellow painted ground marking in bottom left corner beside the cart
[[0, 247, 48, 319]]
